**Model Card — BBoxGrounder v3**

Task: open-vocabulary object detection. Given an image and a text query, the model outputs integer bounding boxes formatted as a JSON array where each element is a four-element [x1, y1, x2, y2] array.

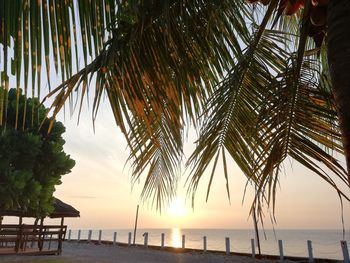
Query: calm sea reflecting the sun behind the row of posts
[[67, 228, 350, 259]]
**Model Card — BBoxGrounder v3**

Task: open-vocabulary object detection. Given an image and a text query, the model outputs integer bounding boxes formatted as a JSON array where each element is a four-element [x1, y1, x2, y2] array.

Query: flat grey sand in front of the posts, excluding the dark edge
[[0, 242, 284, 263]]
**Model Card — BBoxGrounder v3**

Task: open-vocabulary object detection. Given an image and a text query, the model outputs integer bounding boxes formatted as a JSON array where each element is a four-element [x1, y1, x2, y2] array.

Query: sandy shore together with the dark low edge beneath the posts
[[0, 240, 341, 263]]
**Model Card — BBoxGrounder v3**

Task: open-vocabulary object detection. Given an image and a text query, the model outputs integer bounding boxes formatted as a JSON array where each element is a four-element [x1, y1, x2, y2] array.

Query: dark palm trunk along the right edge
[[327, 0, 350, 184]]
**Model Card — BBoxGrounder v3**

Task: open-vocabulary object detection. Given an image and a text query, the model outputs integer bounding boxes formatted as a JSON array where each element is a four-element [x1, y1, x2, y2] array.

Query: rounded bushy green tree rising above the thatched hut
[[0, 89, 75, 219]]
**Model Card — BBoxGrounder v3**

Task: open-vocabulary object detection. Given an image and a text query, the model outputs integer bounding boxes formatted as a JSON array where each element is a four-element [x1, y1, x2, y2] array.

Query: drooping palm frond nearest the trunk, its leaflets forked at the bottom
[[253, 58, 348, 217]]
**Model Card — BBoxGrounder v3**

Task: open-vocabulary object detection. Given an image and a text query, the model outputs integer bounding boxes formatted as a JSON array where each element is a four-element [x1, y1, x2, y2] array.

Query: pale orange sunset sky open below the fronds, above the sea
[[48, 101, 350, 229]]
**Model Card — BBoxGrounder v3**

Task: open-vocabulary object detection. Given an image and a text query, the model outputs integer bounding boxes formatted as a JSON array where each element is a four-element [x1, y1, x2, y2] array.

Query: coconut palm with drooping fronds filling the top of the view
[[0, 0, 350, 214]]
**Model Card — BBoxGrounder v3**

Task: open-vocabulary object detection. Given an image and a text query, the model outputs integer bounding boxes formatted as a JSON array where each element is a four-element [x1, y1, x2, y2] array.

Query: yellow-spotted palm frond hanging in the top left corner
[[0, 0, 119, 126]]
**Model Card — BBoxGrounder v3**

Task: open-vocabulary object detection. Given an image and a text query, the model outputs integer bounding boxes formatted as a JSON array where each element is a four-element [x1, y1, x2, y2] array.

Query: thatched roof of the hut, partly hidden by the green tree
[[0, 198, 80, 218]]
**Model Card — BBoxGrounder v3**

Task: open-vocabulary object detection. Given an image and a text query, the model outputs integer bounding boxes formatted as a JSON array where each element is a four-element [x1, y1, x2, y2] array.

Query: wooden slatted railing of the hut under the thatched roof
[[0, 224, 67, 254]]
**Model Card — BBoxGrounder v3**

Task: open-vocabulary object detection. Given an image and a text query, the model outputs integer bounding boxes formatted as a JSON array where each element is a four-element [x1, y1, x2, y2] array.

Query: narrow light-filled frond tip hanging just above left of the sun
[[129, 114, 183, 211]]
